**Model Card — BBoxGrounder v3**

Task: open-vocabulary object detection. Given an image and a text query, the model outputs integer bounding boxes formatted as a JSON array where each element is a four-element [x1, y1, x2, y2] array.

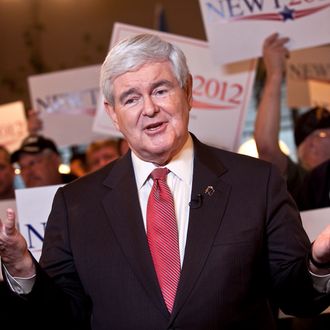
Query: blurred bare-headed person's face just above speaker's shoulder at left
[[86, 139, 119, 172]]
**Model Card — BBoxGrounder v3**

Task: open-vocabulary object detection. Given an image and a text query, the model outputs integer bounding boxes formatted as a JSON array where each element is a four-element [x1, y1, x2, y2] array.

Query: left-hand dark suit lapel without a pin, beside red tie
[[102, 153, 169, 317]]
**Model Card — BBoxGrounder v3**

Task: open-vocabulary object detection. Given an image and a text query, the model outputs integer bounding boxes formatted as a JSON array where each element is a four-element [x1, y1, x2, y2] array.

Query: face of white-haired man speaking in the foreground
[[106, 62, 191, 165]]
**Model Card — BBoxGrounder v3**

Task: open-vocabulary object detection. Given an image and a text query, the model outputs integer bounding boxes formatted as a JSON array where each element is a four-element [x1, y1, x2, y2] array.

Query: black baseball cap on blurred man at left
[[11, 135, 59, 163]]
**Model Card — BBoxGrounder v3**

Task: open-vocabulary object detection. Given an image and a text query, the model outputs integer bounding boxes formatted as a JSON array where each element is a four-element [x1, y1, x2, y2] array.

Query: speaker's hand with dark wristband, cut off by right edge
[[310, 225, 330, 274]]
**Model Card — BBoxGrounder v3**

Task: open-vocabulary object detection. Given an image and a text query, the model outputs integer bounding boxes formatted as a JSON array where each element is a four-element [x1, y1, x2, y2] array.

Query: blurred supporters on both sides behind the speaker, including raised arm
[[0, 33, 330, 210]]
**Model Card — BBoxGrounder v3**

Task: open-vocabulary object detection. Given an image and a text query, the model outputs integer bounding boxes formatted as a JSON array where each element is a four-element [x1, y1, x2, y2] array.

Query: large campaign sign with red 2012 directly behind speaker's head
[[93, 23, 256, 151]]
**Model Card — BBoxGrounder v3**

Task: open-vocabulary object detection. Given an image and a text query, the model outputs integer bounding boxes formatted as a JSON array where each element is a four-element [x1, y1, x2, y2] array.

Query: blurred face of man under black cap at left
[[19, 150, 61, 188]]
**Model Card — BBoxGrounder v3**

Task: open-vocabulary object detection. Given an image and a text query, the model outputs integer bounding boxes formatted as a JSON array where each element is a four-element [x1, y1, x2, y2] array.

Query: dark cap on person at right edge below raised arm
[[294, 108, 330, 147]]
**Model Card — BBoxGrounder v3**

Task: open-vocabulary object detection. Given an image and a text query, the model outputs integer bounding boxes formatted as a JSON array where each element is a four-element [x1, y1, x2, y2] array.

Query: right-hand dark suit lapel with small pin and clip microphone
[[171, 139, 230, 319]]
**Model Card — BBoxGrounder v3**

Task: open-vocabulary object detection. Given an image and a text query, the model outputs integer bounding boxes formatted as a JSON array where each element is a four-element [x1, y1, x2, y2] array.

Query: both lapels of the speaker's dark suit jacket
[[102, 138, 230, 320]]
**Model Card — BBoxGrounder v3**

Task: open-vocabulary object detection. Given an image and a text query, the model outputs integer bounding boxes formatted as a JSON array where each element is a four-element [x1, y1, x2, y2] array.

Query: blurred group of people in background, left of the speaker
[[0, 127, 128, 200]]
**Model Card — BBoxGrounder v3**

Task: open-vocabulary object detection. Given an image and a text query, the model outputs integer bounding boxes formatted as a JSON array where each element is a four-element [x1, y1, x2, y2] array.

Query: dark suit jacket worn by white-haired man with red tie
[[2, 135, 329, 330]]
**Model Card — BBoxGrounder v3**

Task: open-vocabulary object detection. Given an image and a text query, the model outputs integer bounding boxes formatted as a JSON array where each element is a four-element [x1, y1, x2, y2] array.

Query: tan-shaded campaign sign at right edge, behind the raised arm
[[286, 44, 330, 108]]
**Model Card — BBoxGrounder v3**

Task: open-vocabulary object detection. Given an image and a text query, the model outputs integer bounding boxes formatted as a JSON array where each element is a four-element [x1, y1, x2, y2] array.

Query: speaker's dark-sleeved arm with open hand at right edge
[[266, 165, 330, 317]]
